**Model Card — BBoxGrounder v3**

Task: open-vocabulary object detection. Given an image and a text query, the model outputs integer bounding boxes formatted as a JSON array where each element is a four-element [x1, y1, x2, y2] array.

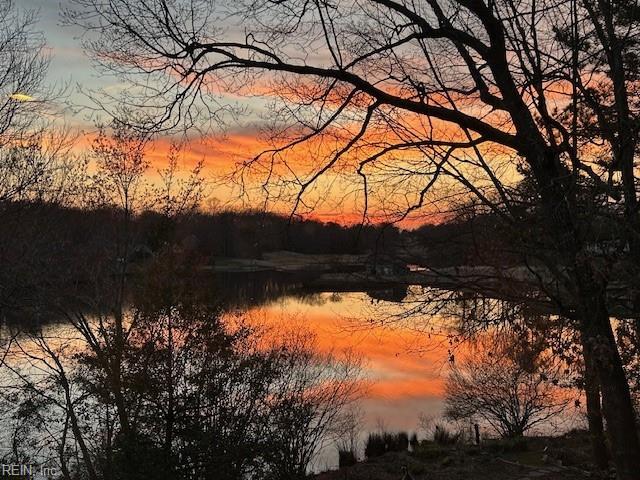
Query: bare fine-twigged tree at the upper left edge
[[0, 0, 83, 314]]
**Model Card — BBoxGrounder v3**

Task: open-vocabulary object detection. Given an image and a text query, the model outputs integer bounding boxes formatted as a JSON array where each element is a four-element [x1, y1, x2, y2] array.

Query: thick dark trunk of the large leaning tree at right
[[530, 141, 640, 480]]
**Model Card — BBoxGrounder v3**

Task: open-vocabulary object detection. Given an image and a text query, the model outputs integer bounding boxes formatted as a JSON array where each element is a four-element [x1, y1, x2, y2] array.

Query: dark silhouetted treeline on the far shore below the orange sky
[[0, 202, 510, 270]]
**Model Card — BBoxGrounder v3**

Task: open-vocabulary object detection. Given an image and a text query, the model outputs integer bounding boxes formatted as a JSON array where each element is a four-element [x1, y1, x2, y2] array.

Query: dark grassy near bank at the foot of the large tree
[[313, 430, 613, 480]]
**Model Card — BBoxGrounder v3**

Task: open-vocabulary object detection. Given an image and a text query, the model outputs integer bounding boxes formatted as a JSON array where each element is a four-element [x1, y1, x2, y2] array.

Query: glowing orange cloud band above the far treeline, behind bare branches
[[74, 89, 520, 227]]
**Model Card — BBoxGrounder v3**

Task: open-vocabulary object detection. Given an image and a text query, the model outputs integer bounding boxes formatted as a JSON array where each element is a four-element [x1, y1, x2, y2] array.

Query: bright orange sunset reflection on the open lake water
[[240, 292, 448, 431]]
